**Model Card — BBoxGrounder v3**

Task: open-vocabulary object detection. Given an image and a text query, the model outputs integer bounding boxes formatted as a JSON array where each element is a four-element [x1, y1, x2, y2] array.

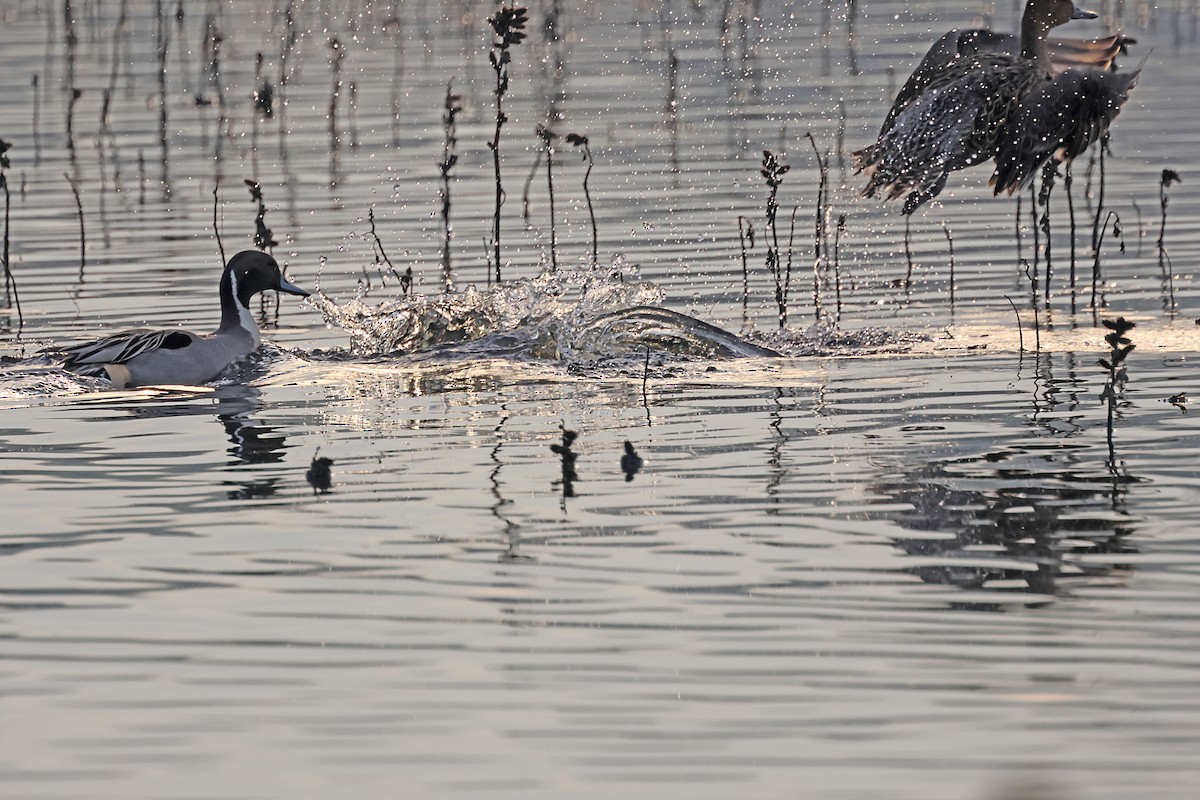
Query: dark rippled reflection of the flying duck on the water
[[874, 449, 1136, 609]]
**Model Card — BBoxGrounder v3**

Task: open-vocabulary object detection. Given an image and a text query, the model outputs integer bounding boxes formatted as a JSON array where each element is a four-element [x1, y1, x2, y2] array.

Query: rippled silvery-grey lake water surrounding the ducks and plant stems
[[0, 1, 1200, 799]]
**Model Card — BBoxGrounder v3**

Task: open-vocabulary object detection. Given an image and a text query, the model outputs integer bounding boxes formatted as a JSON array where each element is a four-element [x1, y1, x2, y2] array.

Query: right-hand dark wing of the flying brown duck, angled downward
[[991, 70, 1141, 194]]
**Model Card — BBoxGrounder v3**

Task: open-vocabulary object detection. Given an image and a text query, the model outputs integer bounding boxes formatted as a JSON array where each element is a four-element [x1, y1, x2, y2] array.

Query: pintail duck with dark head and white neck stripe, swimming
[[61, 249, 308, 389]]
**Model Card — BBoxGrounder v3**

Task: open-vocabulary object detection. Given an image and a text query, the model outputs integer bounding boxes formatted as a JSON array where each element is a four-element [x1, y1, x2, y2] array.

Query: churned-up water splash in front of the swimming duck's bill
[[313, 258, 913, 362]]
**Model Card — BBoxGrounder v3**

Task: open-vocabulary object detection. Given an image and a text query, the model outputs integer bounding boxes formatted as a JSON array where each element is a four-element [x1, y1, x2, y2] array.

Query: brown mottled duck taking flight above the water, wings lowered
[[853, 0, 1136, 215]]
